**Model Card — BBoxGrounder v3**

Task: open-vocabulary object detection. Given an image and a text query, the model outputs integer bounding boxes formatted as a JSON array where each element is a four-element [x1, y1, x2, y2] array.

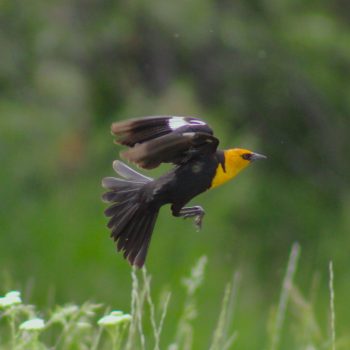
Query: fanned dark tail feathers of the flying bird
[[102, 161, 159, 268]]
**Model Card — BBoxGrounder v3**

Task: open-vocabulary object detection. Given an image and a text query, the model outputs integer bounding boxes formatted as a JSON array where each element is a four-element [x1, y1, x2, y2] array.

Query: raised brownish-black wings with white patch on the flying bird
[[112, 116, 219, 169]]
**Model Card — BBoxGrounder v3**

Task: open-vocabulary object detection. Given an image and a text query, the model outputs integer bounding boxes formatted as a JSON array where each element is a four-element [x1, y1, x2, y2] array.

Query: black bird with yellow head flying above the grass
[[102, 116, 266, 267]]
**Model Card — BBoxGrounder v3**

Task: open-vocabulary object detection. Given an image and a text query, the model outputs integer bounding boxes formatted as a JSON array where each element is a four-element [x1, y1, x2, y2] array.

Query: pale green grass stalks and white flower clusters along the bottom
[[0, 247, 344, 350]]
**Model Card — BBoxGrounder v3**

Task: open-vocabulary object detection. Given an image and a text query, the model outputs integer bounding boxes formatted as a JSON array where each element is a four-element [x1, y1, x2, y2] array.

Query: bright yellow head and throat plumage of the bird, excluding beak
[[210, 148, 253, 188]]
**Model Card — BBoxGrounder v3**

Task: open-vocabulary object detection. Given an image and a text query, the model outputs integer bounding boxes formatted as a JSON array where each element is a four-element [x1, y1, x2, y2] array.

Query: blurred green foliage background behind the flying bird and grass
[[0, 0, 350, 349]]
